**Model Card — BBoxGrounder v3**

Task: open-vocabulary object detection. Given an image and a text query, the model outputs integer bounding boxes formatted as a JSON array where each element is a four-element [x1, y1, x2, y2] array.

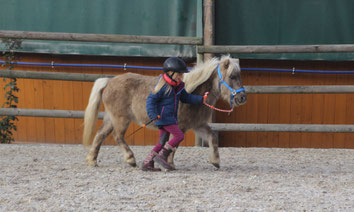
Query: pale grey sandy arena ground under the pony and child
[[0, 144, 354, 211]]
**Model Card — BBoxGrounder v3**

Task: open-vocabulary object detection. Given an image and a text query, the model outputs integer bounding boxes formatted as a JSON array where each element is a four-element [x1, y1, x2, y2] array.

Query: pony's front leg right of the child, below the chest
[[194, 124, 220, 168]]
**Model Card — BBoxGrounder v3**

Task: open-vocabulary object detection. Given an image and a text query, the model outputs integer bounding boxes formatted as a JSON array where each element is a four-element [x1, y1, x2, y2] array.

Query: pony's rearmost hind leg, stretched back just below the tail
[[86, 119, 113, 166]]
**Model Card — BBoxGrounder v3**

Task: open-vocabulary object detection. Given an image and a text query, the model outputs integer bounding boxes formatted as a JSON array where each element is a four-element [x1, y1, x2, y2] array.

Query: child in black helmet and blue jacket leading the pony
[[141, 57, 203, 171]]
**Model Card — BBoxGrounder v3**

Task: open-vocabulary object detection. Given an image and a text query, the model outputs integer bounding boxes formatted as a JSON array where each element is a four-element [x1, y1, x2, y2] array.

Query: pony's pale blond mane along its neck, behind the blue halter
[[183, 55, 232, 93]]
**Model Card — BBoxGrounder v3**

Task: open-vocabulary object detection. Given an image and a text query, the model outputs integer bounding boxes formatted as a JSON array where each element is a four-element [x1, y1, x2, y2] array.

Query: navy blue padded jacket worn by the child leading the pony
[[146, 83, 203, 126]]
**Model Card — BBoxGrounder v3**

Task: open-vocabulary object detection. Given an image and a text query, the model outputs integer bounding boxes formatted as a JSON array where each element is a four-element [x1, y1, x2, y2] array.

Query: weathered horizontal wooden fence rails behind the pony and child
[[0, 31, 354, 148]]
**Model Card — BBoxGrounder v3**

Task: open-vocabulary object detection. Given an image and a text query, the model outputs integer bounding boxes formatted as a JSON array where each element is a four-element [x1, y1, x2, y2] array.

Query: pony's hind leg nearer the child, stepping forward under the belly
[[113, 117, 136, 167]]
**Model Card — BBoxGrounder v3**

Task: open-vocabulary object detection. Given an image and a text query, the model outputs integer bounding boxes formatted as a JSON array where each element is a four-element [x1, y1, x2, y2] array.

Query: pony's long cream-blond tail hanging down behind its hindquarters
[[82, 78, 109, 146]]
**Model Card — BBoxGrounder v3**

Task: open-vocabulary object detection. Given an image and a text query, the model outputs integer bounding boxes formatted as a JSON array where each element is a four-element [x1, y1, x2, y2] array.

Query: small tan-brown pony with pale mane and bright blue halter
[[82, 56, 247, 168]]
